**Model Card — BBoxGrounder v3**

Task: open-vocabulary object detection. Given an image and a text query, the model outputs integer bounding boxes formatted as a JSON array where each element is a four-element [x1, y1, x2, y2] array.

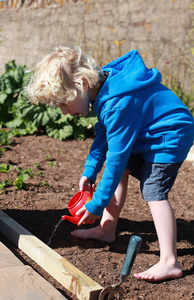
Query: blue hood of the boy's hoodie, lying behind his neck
[[96, 50, 161, 100]]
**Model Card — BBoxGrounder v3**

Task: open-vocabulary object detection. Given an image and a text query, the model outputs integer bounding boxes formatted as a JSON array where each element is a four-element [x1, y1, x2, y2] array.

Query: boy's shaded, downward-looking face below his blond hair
[[57, 91, 89, 117]]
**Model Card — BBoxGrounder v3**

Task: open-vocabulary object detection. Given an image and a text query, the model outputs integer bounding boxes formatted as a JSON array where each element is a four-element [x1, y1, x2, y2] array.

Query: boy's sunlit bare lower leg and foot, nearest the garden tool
[[134, 200, 182, 281]]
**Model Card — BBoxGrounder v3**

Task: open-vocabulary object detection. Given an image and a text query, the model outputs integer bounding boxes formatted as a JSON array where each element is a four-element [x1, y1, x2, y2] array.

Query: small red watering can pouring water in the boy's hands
[[61, 190, 92, 224]]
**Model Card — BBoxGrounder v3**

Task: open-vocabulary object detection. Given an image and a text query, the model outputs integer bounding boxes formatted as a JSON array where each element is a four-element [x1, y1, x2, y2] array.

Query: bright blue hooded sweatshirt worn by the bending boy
[[82, 50, 194, 215]]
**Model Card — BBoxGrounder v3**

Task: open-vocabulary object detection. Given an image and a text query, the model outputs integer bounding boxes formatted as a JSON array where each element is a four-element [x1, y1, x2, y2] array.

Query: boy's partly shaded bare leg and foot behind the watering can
[[71, 169, 129, 242]]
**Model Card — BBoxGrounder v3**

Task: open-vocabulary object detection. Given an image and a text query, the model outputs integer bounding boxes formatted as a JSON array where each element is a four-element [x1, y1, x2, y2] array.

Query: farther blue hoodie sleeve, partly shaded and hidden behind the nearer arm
[[82, 122, 108, 182]]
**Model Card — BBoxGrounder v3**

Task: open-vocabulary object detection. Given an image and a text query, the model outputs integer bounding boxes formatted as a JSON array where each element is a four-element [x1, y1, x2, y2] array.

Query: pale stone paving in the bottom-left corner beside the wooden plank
[[0, 242, 66, 300]]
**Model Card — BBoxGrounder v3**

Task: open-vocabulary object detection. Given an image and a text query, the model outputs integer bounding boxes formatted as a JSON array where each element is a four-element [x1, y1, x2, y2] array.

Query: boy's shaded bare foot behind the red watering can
[[71, 225, 115, 243]]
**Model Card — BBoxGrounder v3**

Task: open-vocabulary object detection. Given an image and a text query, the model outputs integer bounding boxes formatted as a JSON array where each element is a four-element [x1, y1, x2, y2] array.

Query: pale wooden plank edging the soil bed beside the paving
[[0, 210, 103, 300]]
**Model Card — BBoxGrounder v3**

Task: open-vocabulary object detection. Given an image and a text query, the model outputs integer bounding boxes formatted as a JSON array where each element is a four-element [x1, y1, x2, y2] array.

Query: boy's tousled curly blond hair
[[24, 46, 103, 106]]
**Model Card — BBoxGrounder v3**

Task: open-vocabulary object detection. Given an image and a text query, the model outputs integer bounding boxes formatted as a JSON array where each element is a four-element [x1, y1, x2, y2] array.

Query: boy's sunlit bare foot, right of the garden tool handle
[[134, 262, 183, 281]]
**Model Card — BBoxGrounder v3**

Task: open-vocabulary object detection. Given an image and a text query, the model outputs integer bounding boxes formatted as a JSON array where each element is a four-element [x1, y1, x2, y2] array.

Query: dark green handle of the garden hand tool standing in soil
[[121, 235, 142, 281]]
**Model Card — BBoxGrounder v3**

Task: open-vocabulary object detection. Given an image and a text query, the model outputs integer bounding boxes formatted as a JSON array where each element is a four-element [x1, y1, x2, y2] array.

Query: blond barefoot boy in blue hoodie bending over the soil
[[26, 47, 194, 281]]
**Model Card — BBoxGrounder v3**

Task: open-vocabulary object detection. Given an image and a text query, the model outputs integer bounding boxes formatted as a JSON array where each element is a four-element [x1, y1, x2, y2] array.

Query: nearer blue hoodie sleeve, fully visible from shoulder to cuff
[[85, 109, 142, 215]]
